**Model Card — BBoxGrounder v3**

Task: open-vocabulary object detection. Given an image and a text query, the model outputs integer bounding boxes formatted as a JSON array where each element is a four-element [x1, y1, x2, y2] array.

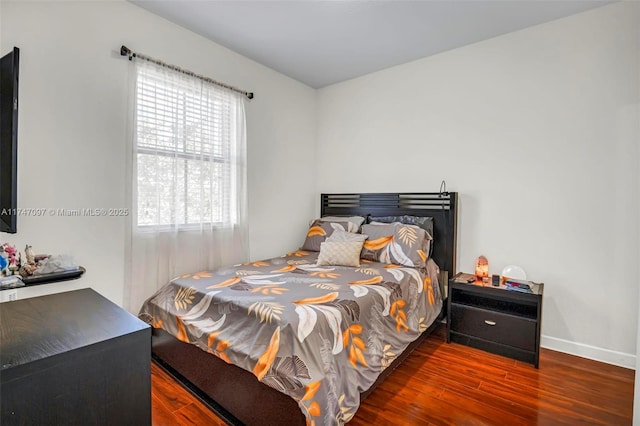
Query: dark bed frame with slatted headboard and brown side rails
[[152, 192, 458, 425]]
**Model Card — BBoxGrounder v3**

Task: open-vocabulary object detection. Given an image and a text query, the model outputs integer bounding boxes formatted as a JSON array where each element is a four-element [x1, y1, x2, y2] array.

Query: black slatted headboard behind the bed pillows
[[320, 192, 458, 277]]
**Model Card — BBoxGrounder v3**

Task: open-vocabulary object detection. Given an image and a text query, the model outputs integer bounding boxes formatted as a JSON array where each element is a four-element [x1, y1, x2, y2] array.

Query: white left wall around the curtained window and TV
[[0, 0, 317, 304]]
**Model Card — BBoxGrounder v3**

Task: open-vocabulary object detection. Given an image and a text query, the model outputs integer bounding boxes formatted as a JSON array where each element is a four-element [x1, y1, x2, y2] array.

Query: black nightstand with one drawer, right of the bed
[[447, 277, 544, 368]]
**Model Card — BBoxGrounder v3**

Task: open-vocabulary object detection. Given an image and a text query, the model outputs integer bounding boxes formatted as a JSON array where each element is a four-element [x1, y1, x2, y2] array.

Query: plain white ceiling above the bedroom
[[130, 0, 610, 88]]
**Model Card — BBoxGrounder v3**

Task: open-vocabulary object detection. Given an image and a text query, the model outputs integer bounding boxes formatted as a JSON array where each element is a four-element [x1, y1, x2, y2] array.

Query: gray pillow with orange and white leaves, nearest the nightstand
[[361, 222, 430, 268]]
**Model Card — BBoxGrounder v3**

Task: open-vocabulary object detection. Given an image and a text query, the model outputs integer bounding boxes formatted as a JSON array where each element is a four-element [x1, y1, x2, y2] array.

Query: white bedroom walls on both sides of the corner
[[0, 1, 640, 366]]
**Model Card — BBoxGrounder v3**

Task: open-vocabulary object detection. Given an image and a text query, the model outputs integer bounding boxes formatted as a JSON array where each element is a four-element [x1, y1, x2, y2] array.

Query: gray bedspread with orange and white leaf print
[[140, 251, 442, 425]]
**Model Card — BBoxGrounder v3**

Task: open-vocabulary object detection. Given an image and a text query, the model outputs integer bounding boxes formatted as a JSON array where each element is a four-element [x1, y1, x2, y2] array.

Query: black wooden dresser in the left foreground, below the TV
[[0, 289, 151, 426]]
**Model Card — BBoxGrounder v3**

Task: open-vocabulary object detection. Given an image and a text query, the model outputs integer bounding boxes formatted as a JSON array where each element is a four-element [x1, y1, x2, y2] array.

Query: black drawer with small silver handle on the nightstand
[[449, 304, 536, 351]]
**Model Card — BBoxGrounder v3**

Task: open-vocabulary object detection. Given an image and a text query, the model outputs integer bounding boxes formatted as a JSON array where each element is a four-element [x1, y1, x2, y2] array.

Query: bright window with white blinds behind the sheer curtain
[[133, 63, 244, 230]]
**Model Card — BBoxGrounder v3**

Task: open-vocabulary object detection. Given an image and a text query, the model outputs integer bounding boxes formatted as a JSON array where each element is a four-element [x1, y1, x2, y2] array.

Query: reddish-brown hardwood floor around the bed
[[152, 326, 634, 426]]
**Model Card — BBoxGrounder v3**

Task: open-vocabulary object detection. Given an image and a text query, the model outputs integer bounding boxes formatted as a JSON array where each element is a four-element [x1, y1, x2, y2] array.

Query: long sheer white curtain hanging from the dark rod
[[124, 60, 248, 313]]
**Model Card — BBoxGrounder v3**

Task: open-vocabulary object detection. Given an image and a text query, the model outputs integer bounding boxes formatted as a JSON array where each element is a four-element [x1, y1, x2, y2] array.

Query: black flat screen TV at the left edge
[[0, 47, 20, 234]]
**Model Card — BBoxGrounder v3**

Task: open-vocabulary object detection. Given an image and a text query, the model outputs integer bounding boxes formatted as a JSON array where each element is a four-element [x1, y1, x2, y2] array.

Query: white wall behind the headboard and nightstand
[[317, 3, 640, 367]]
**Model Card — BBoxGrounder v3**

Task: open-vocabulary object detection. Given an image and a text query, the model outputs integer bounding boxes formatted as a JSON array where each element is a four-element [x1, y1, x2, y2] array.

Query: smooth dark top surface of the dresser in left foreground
[[0, 288, 149, 371]]
